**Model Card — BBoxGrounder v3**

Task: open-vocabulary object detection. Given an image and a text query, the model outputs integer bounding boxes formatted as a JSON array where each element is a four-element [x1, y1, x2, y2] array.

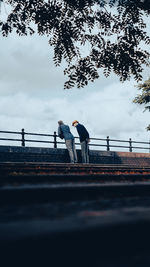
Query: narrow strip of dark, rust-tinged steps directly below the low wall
[[0, 162, 150, 177]]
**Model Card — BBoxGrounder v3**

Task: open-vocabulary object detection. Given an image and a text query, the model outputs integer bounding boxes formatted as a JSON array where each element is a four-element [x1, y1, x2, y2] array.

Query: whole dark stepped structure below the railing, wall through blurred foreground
[[0, 138, 150, 267]]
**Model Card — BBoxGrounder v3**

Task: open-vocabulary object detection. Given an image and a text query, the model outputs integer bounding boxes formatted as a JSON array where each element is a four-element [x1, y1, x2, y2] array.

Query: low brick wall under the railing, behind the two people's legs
[[0, 146, 150, 166]]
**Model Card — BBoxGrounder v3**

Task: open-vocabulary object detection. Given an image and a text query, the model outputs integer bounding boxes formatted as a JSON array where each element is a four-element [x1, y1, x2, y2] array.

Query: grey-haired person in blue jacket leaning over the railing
[[58, 120, 78, 163]]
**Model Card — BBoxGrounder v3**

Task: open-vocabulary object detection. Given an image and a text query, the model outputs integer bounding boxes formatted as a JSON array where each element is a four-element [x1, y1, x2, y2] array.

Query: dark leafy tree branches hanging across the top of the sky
[[0, 0, 150, 89]]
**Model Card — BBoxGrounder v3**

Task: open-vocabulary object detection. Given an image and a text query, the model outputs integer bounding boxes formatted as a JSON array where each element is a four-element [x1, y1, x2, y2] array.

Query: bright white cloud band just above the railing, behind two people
[[0, 82, 149, 147]]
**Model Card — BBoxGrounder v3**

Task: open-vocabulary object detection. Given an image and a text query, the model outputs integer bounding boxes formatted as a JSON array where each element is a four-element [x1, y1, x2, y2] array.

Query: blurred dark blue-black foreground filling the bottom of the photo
[[0, 182, 150, 267]]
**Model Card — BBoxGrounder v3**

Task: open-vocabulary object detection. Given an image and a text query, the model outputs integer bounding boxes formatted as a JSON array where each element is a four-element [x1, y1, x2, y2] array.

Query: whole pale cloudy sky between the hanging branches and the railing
[[0, 3, 150, 152]]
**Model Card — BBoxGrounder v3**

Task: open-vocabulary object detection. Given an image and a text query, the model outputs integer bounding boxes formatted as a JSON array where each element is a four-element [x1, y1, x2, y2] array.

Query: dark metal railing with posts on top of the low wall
[[0, 129, 150, 153]]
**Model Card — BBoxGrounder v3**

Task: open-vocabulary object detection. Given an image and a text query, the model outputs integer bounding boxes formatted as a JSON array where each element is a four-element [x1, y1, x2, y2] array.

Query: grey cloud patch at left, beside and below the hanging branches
[[0, 34, 64, 95]]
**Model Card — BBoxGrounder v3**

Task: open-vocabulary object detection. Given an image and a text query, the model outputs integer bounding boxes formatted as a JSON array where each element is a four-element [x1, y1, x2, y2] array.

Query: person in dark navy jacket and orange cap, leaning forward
[[72, 120, 90, 163]]
